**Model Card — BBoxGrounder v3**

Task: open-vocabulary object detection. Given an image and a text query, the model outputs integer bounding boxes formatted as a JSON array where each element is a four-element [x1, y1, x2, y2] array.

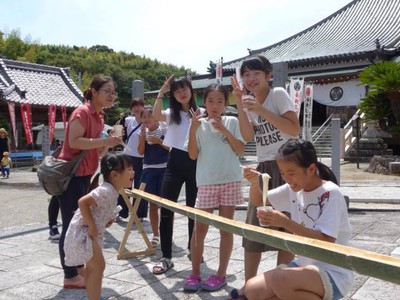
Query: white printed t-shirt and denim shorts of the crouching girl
[[268, 181, 354, 295]]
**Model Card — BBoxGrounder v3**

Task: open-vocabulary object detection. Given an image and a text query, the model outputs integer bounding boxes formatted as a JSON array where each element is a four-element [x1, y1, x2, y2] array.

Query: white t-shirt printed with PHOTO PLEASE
[[247, 87, 295, 162]]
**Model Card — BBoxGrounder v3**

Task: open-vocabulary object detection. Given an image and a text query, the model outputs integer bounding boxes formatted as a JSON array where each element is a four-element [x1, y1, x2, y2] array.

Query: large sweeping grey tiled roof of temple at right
[[224, 0, 400, 69]]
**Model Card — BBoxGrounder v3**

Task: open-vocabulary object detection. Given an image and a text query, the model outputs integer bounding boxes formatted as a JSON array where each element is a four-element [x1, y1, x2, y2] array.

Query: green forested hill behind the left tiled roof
[[0, 30, 194, 113]]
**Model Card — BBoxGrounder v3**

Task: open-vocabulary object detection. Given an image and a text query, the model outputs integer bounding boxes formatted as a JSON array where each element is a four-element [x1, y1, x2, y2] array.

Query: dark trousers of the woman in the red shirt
[[57, 175, 92, 279]]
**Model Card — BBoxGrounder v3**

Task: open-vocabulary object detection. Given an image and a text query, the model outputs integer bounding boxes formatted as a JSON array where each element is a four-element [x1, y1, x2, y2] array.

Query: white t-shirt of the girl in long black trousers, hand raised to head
[[164, 108, 205, 151]]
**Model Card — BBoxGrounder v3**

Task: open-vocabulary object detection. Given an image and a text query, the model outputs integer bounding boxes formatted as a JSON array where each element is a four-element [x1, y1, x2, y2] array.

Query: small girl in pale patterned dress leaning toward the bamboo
[[64, 154, 134, 300]]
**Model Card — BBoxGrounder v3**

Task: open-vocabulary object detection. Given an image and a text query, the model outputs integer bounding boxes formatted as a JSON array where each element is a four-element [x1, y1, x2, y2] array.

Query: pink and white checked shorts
[[195, 181, 244, 208]]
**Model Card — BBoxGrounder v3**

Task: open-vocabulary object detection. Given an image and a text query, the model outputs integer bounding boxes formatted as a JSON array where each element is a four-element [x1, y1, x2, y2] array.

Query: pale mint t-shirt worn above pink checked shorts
[[185, 116, 244, 186]]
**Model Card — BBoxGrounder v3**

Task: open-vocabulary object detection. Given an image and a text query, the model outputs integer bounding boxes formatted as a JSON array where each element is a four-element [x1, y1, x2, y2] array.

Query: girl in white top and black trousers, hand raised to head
[[153, 75, 204, 274]]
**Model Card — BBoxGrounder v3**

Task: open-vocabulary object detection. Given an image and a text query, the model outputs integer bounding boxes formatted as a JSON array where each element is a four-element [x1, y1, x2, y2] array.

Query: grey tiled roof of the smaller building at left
[[0, 59, 83, 107]]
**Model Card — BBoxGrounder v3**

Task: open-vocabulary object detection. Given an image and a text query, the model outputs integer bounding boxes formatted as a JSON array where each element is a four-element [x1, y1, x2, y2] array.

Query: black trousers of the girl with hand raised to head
[[160, 148, 197, 258]]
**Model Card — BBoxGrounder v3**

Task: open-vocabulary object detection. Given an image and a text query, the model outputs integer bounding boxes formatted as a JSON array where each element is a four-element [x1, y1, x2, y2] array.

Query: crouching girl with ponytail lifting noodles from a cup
[[244, 139, 354, 299]]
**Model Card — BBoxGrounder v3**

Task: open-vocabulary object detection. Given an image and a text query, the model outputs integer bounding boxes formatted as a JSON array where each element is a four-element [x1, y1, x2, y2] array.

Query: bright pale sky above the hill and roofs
[[0, 0, 351, 74]]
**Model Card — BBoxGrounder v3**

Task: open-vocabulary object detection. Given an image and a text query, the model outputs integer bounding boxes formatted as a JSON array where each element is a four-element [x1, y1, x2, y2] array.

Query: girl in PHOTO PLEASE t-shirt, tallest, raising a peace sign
[[230, 55, 300, 299]]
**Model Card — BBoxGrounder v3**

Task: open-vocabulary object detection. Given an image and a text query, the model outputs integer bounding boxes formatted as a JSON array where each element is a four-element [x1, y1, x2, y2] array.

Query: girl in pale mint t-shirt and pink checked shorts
[[184, 84, 244, 291]]
